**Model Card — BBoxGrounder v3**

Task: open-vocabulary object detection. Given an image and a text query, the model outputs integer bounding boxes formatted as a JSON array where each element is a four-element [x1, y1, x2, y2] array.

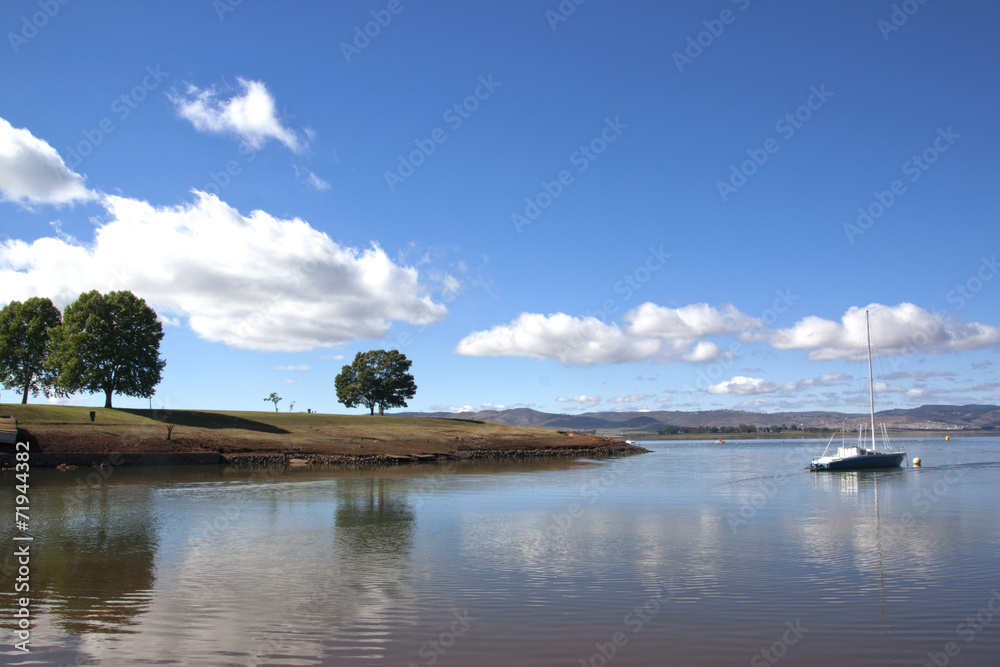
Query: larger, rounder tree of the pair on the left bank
[[49, 290, 167, 408]]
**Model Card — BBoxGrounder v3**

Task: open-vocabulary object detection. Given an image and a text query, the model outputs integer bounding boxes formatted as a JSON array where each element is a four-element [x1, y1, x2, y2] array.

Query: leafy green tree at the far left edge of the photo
[[0, 296, 64, 403]]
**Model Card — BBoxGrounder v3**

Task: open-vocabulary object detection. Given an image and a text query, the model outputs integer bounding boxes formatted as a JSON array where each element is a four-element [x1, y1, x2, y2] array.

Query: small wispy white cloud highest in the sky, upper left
[[170, 78, 302, 153]]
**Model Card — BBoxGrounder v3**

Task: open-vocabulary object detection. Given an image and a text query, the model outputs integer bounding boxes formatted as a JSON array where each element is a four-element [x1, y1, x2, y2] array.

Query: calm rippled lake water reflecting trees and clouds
[[0, 438, 1000, 667]]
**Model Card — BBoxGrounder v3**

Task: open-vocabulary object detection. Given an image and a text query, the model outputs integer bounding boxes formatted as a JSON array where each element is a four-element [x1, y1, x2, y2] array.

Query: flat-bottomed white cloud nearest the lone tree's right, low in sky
[[454, 313, 659, 366]]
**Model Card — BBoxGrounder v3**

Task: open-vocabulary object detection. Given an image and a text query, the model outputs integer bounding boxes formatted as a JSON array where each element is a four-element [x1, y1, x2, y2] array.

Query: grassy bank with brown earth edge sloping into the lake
[[5, 405, 648, 456]]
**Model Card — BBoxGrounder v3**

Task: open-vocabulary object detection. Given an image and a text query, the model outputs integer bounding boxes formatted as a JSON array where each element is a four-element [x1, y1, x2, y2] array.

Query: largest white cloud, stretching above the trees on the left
[[0, 192, 447, 352]]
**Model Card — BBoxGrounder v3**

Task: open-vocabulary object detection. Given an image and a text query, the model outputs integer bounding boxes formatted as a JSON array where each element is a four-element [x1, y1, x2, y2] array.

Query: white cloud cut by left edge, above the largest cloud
[[0, 118, 98, 206]]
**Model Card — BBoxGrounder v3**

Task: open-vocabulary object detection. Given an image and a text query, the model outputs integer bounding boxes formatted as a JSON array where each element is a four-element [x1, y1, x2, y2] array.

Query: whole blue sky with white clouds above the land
[[0, 0, 1000, 412]]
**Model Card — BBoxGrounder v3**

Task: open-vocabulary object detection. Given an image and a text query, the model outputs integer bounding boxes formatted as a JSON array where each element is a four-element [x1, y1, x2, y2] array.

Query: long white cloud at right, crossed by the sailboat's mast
[[771, 303, 1000, 361]]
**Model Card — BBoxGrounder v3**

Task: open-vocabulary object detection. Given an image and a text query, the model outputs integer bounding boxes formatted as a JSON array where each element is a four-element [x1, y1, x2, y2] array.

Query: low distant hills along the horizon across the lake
[[396, 405, 1000, 433]]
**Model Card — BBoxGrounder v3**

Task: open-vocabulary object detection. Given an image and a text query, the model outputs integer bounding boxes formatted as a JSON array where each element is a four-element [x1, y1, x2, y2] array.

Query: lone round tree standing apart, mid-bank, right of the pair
[[336, 350, 417, 415]]
